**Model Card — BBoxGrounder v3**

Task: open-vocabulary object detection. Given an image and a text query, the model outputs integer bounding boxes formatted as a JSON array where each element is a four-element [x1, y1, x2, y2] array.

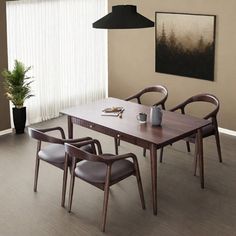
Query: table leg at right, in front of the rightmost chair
[[197, 129, 204, 188]]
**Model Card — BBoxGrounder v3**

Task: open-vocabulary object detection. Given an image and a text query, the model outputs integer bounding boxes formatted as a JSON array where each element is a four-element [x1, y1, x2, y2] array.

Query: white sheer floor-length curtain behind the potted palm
[[7, 0, 108, 124]]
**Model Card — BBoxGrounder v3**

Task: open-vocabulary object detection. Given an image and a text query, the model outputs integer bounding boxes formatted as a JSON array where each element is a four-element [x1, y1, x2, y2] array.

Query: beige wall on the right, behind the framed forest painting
[[108, 0, 236, 130]]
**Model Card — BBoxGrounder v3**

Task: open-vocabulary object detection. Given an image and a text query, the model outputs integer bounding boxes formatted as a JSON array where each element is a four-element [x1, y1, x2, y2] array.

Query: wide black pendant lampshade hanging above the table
[[93, 5, 154, 29]]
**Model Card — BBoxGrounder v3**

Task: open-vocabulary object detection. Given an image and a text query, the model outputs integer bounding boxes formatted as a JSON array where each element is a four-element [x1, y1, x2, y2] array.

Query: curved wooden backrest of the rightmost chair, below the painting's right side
[[171, 93, 220, 119]]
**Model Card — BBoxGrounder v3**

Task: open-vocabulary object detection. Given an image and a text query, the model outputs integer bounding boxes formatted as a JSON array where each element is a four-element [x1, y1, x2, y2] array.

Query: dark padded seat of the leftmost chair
[[38, 144, 92, 169]]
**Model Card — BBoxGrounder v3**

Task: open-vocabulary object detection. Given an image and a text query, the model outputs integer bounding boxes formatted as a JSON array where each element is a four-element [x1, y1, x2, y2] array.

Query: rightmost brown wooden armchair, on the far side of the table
[[160, 94, 222, 175]]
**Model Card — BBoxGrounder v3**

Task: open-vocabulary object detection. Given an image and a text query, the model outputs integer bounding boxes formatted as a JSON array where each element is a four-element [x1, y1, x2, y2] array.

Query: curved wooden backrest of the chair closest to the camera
[[65, 143, 106, 163]]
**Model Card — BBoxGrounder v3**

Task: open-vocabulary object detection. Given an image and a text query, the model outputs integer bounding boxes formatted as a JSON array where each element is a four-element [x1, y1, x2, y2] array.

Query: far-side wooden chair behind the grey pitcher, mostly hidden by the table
[[114, 85, 168, 156]]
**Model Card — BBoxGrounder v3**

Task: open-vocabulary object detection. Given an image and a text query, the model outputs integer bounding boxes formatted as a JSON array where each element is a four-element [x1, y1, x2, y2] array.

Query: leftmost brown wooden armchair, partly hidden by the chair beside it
[[28, 127, 93, 207]]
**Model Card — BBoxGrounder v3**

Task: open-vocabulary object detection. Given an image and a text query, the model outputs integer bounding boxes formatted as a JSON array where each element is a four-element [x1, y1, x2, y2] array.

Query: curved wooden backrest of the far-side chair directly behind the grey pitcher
[[125, 85, 168, 109]]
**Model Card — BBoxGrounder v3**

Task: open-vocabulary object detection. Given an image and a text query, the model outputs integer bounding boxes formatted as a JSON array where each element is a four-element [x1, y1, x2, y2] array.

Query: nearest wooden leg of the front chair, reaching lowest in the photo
[[102, 165, 111, 232]]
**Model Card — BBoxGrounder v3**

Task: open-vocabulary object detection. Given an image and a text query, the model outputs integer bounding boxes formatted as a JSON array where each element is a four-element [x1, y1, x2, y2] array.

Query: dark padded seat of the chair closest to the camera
[[75, 155, 134, 184]]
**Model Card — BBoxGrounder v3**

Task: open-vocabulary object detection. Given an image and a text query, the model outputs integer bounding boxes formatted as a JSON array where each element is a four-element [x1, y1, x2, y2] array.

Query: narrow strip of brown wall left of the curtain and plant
[[0, 0, 10, 131]]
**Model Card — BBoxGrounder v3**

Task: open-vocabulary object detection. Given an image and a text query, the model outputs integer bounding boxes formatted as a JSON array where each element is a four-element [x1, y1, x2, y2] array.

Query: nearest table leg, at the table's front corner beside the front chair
[[150, 144, 157, 215]]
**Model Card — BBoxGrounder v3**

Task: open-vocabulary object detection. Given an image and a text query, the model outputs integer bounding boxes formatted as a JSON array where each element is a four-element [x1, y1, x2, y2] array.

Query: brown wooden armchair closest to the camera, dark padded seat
[[65, 140, 145, 232]]
